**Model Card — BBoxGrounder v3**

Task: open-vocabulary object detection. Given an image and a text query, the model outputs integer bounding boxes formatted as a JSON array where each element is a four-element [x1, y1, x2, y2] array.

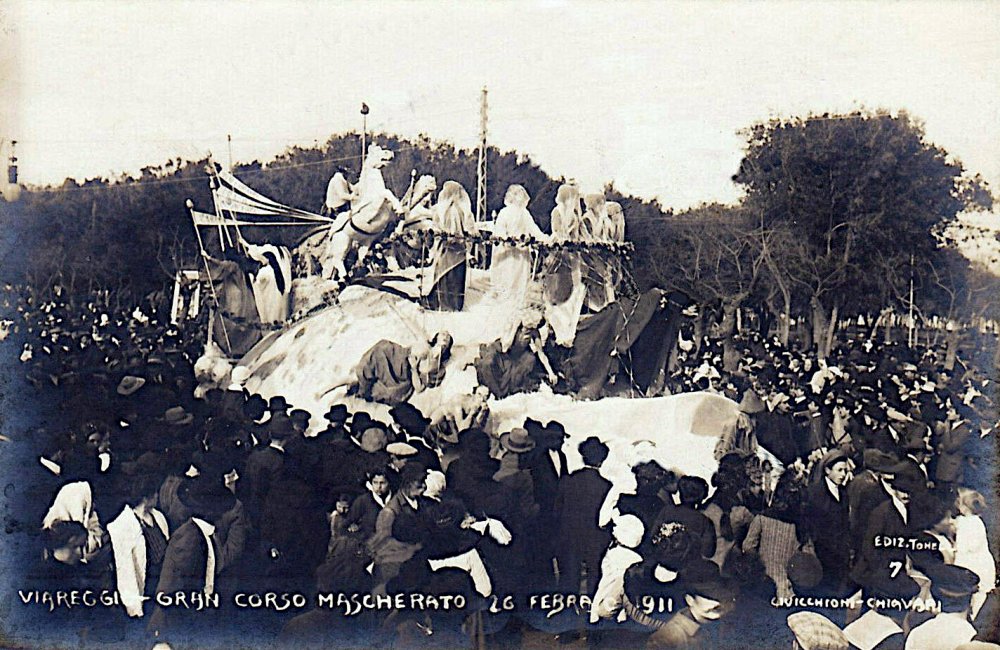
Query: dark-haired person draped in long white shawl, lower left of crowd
[[108, 472, 170, 618]]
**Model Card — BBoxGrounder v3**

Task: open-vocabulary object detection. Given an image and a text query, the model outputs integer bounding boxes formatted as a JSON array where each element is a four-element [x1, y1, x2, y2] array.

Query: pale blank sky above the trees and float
[[0, 0, 1000, 208]]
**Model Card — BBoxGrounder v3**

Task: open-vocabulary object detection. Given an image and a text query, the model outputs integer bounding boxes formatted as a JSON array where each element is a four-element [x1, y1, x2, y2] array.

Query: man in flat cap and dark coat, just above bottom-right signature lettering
[[803, 449, 851, 597]]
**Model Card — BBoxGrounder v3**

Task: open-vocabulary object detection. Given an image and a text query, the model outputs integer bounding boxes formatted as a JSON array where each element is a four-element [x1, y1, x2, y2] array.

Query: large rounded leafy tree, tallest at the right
[[733, 111, 970, 355]]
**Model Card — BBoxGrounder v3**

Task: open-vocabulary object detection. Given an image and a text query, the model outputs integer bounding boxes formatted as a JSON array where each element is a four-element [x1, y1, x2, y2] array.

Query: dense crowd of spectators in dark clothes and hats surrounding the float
[[0, 287, 998, 648]]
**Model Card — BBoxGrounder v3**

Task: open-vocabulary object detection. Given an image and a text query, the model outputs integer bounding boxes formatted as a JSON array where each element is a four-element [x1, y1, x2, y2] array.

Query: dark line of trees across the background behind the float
[[0, 111, 1000, 355]]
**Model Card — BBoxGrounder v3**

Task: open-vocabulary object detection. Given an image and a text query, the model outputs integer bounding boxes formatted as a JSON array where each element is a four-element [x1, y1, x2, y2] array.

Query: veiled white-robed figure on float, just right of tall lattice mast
[[490, 185, 547, 310]]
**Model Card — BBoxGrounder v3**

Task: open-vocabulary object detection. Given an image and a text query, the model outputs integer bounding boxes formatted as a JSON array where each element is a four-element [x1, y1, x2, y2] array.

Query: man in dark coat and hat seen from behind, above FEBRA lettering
[[555, 436, 612, 594]]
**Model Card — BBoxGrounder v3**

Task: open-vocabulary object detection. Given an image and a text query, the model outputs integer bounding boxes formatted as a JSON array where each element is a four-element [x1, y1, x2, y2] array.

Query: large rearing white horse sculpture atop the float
[[322, 144, 402, 279]]
